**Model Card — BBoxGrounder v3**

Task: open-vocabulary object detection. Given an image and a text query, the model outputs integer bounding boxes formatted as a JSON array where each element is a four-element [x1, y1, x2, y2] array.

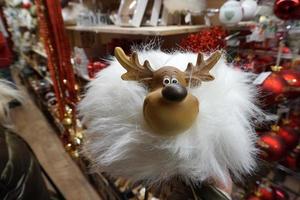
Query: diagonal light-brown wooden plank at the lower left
[[11, 70, 102, 200]]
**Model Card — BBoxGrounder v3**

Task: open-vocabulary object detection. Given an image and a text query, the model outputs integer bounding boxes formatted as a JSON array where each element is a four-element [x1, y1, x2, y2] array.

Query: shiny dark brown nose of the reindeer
[[161, 84, 187, 102]]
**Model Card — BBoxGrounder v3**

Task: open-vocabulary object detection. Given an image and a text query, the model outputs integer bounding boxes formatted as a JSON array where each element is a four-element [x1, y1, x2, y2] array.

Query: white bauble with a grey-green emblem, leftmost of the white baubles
[[219, 0, 243, 26]]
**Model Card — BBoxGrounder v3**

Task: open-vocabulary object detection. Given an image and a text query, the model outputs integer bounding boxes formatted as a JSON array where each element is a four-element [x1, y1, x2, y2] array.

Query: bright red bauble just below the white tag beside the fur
[[260, 73, 288, 105]]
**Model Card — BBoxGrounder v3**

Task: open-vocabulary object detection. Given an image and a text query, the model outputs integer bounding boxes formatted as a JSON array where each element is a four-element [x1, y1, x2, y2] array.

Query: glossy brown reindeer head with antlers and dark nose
[[115, 47, 221, 136]]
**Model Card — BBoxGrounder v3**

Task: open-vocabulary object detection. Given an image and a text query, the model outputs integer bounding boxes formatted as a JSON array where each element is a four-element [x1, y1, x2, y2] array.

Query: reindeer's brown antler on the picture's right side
[[185, 51, 222, 87]]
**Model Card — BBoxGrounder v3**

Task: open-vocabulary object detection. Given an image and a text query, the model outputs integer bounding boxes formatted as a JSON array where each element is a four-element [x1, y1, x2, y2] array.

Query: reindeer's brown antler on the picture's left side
[[115, 47, 154, 81]]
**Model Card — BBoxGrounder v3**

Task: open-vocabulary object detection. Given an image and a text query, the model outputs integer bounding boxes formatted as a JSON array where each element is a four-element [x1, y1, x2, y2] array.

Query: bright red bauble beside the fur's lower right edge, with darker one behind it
[[257, 132, 286, 161]]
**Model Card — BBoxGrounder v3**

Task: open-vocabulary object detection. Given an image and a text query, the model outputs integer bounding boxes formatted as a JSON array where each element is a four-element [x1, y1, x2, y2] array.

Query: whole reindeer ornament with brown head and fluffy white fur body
[[79, 47, 261, 192]]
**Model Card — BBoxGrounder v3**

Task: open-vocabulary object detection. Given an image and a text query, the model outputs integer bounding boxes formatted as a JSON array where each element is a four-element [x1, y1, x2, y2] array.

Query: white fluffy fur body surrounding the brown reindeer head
[[79, 50, 260, 183]]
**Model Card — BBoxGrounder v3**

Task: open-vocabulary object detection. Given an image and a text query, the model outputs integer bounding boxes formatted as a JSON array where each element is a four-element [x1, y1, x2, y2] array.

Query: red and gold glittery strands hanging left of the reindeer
[[35, 0, 81, 155]]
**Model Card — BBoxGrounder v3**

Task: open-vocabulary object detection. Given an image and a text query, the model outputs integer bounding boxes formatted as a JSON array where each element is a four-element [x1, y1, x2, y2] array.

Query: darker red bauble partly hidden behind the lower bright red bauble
[[277, 126, 300, 150]]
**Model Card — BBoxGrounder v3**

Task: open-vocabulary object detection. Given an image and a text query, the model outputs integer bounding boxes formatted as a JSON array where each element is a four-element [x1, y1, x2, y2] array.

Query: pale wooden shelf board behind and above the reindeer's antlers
[[66, 25, 207, 36]]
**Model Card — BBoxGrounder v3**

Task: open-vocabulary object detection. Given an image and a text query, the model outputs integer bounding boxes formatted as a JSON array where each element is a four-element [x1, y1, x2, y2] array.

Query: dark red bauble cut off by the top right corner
[[274, 0, 300, 20]]
